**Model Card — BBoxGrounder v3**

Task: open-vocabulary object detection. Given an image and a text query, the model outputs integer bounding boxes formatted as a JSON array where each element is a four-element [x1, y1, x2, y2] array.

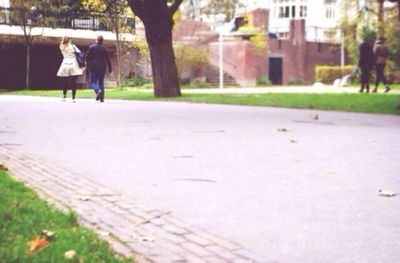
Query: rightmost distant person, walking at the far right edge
[[373, 37, 390, 93]]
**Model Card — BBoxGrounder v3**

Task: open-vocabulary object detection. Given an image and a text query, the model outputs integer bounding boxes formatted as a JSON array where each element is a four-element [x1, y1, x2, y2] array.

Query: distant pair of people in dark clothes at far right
[[358, 37, 390, 93]]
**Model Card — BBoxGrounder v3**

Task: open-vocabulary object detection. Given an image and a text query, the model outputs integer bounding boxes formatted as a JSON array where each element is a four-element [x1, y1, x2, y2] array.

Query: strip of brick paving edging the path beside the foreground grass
[[0, 145, 264, 262]]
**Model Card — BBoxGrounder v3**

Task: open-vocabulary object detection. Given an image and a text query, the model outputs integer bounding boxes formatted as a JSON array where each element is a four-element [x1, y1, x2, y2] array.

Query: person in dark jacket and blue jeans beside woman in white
[[86, 36, 112, 102]]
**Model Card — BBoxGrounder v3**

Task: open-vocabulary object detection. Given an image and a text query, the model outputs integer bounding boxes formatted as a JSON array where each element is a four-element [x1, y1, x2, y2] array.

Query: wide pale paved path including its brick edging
[[0, 96, 400, 262]]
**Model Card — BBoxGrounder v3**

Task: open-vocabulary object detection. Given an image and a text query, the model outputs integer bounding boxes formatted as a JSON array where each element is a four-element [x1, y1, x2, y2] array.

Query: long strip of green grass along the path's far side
[[6, 88, 400, 114]]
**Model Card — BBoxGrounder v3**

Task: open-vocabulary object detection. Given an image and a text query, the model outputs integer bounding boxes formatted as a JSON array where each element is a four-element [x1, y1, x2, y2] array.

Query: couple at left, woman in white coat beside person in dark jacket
[[57, 36, 112, 102]]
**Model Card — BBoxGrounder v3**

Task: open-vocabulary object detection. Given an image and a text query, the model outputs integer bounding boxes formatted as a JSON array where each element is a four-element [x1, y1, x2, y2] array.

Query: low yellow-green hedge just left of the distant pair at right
[[315, 65, 356, 84]]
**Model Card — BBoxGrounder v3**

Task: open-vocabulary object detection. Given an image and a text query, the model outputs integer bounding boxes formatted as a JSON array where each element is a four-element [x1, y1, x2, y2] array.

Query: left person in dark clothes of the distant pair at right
[[358, 39, 375, 93]]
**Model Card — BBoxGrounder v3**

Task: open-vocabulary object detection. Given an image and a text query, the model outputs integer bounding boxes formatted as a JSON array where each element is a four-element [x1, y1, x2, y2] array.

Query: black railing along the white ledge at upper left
[[0, 8, 135, 34]]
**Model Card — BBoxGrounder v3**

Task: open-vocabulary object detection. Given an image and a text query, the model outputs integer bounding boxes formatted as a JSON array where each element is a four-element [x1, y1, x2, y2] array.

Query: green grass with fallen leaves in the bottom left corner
[[0, 169, 129, 263]]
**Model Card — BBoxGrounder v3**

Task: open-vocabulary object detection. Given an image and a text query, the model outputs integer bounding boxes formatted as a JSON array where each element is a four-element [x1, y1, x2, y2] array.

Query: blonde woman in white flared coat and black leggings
[[57, 37, 84, 102]]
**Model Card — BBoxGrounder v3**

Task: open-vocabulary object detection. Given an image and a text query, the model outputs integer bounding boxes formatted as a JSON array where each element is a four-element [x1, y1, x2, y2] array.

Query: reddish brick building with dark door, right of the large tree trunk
[[209, 9, 340, 85]]
